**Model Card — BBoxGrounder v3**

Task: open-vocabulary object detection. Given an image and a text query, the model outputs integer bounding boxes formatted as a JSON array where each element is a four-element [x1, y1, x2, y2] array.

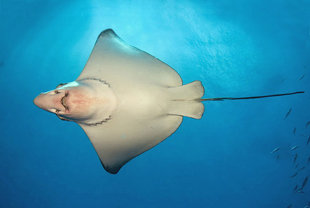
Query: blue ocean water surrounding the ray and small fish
[[0, 0, 310, 208]]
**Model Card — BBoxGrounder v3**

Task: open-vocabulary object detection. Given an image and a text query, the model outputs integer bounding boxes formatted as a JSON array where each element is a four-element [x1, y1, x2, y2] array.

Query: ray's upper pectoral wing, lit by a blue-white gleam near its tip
[[77, 29, 182, 88]]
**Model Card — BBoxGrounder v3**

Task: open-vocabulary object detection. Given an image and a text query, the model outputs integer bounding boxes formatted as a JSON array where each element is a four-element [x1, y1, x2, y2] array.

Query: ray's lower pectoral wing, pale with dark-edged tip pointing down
[[79, 113, 182, 174]]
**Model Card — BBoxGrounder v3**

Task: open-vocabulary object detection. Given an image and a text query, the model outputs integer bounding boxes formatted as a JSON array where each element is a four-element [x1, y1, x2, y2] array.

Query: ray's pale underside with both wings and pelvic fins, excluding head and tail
[[77, 29, 203, 174]]
